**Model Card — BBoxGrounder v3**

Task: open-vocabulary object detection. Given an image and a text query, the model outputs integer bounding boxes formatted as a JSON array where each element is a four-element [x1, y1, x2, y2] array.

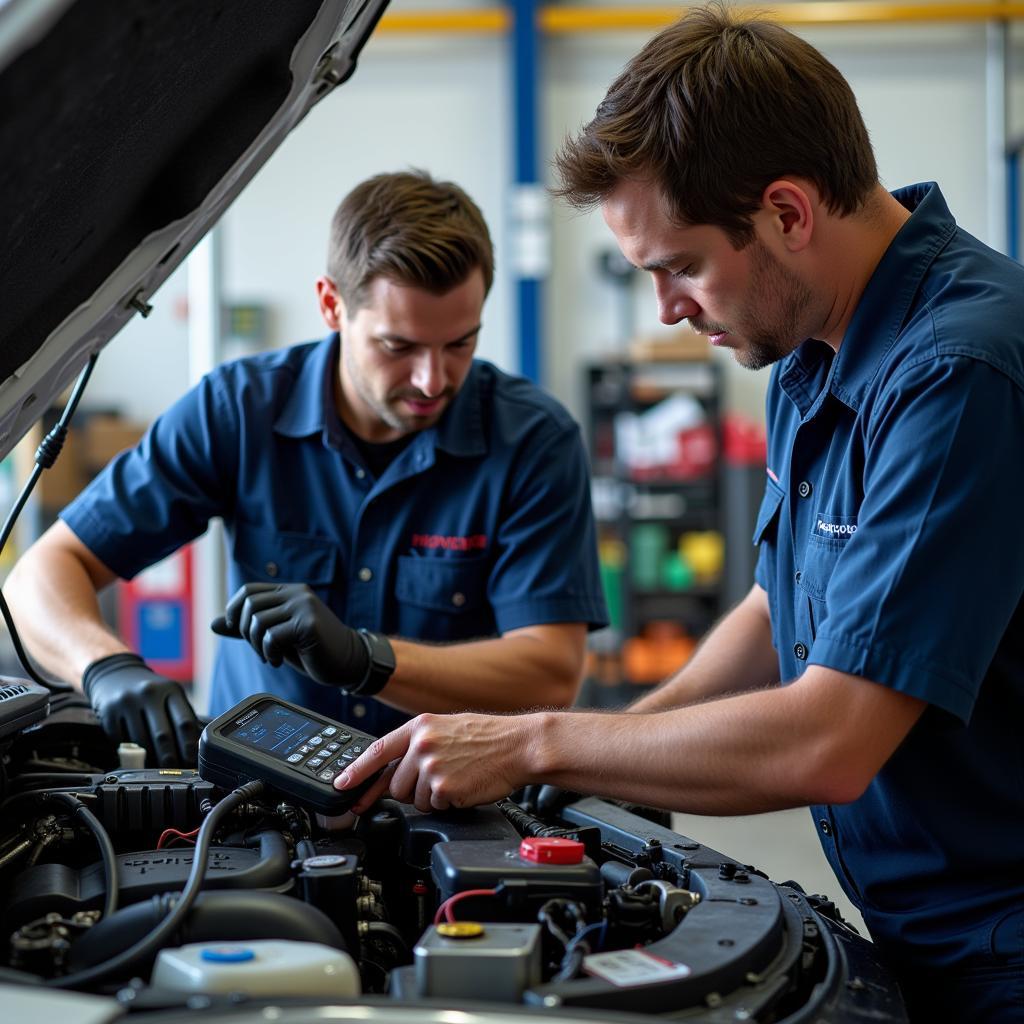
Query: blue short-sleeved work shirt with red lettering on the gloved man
[[61, 334, 606, 734]]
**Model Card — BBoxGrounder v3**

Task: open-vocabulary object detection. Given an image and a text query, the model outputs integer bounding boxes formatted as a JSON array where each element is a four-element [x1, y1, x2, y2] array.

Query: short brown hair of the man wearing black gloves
[[327, 170, 495, 313]]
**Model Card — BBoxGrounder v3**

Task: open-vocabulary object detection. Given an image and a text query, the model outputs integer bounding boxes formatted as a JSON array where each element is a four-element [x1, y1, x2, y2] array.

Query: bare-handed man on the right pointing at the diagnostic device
[[336, 6, 1024, 1024]]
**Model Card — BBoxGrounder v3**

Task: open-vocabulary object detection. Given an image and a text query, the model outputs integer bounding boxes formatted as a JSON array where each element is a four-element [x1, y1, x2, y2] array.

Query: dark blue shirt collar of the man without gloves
[[778, 181, 956, 415]]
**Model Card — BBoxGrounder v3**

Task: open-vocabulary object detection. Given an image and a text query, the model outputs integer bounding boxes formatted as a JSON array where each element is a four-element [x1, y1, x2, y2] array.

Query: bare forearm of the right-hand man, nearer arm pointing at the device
[[528, 667, 924, 814]]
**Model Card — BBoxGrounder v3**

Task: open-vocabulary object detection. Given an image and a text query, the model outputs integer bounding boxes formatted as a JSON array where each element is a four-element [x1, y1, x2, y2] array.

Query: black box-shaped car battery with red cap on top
[[430, 839, 602, 921]]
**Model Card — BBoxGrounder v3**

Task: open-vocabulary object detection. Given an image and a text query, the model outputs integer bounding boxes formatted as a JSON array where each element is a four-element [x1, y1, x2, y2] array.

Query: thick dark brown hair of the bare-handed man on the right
[[553, 3, 878, 248]]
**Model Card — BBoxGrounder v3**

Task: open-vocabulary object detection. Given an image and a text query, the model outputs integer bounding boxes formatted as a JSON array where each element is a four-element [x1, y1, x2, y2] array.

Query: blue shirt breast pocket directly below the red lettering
[[395, 555, 495, 640]]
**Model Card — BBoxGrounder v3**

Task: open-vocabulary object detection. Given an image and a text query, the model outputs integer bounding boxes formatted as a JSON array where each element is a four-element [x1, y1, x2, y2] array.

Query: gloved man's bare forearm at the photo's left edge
[[4, 532, 129, 685]]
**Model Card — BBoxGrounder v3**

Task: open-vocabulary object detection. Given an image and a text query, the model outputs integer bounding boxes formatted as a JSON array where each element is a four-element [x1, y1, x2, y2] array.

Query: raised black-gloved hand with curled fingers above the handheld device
[[210, 583, 370, 687]]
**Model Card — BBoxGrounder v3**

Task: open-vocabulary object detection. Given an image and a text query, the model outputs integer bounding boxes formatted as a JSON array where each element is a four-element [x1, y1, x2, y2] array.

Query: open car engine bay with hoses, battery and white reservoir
[[0, 680, 905, 1022]]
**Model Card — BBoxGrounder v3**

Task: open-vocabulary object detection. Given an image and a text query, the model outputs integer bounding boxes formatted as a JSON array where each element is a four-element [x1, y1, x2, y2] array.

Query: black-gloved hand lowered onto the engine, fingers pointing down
[[82, 653, 201, 768]]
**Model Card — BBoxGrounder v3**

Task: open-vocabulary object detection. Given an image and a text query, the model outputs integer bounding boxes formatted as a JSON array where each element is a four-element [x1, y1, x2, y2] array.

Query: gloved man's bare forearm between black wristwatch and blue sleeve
[[380, 625, 586, 715]]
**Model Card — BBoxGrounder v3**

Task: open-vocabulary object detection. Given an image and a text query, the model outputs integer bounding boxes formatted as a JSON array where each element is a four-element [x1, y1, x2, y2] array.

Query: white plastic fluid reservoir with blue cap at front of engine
[[152, 939, 360, 998]]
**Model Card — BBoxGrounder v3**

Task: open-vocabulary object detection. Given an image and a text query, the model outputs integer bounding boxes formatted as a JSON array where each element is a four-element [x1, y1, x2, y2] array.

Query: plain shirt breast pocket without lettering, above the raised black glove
[[231, 523, 339, 598]]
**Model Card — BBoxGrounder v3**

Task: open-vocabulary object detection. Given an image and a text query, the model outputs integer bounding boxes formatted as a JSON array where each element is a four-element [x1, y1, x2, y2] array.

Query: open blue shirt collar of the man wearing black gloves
[[273, 331, 486, 456]]
